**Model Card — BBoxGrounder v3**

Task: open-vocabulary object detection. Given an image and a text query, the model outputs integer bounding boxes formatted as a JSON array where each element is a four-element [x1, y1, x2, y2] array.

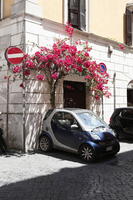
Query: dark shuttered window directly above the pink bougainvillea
[[68, 0, 86, 30]]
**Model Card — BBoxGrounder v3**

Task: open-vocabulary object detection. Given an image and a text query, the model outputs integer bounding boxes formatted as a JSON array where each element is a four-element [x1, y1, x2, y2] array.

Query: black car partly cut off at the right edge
[[109, 107, 133, 139]]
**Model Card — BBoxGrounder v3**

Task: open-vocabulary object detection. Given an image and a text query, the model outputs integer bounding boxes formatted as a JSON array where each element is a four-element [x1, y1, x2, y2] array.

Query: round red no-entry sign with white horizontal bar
[[5, 47, 24, 64]]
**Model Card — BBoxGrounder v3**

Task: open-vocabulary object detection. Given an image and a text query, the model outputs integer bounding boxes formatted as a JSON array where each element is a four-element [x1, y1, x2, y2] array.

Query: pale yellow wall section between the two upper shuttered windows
[[89, 0, 129, 42]]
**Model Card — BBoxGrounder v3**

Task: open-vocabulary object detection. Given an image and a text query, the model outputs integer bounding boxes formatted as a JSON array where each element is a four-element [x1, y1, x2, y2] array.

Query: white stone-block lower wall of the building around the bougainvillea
[[0, 1, 133, 151]]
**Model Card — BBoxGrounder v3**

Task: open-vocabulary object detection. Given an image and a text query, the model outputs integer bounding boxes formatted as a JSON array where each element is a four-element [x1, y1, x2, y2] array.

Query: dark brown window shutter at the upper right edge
[[125, 9, 132, 46]]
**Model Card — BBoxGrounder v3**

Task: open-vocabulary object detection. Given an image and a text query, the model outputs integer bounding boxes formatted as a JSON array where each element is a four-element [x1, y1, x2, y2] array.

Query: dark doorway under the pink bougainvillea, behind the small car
[[63, 81, 86, 108]]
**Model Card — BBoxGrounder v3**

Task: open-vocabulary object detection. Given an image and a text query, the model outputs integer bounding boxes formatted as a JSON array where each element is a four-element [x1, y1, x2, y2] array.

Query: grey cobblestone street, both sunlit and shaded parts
[[0, 142, 133, 200]]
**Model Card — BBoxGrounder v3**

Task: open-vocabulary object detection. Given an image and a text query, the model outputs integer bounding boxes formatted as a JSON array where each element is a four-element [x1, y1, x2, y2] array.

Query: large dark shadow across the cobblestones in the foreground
[[0, 151, 133, 200]]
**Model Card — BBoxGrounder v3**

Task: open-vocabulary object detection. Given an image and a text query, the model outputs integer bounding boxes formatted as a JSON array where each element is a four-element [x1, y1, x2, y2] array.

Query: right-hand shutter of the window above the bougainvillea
[[80, 0, 86, 30]]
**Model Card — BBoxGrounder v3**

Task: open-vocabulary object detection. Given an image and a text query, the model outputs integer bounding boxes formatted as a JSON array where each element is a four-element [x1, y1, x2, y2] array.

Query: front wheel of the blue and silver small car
[[79, 144, 96, 162]]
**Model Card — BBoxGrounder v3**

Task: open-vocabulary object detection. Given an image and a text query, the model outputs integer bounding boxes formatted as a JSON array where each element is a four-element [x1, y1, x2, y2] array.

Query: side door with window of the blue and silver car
[[51, 112, 83, 149]]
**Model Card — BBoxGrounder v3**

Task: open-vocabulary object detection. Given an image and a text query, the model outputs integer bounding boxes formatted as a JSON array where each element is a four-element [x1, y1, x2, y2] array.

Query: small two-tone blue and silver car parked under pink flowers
[[39, 108, 120, 162]]
